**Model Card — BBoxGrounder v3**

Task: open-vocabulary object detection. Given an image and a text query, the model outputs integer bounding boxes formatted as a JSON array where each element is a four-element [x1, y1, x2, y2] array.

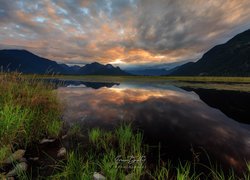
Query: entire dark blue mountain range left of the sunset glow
[[0, 50, 129, 75]]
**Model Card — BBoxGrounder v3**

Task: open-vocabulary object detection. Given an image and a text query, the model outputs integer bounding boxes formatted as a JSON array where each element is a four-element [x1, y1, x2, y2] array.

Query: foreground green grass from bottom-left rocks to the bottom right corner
[[49, 124, 250, 180]]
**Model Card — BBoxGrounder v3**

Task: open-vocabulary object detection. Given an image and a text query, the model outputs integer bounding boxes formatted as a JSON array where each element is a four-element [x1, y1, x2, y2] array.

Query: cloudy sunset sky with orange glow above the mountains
[[0, 0, 250, 68]]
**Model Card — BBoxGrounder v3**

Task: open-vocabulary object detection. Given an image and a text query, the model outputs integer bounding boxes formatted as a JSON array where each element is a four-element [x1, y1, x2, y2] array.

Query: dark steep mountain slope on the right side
[[171, 29, 250, 76]]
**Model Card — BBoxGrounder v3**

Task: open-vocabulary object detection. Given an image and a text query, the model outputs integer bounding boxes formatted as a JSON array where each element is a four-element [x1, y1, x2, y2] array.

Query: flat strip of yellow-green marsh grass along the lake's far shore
[[30, 75, 250, 92]]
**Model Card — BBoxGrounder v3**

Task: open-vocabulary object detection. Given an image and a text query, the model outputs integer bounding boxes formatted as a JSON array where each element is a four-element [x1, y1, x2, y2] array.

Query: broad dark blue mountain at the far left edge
[[0, 50, 64, 74]]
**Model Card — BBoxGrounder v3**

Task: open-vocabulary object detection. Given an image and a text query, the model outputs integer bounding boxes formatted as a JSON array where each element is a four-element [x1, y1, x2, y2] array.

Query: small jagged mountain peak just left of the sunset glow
[[78, 62, 129, 75]]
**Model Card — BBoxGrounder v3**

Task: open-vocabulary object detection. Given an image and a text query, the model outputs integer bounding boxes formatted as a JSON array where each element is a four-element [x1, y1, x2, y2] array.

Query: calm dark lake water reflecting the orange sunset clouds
[[58, 82, 250, 169]]
